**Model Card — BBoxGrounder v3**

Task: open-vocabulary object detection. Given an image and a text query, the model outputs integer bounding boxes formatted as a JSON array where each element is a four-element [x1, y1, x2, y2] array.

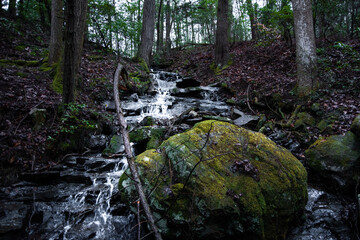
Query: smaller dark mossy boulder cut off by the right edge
[[305, 132, 360, 193]]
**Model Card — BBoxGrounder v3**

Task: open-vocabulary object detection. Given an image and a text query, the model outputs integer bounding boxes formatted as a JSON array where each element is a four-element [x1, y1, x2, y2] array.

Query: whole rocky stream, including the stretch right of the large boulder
[[0, 71, 352, 240]]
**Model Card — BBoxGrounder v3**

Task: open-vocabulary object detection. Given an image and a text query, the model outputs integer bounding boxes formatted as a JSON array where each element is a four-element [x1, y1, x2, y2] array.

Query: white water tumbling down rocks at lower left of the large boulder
[[49, 157, 128, 240]]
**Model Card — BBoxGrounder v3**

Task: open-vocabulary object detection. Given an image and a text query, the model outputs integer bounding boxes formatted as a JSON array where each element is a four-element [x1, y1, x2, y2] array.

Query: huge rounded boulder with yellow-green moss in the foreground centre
[[119, 120, 307, 239]]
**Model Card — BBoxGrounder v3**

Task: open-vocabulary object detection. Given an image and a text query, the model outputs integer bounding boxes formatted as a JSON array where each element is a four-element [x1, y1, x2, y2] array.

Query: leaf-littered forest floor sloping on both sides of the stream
[[0, 15, 360, 185]]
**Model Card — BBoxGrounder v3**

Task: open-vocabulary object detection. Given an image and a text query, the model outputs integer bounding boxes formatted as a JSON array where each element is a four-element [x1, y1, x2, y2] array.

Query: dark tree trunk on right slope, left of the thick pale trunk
[[215, 0, 229, 66]]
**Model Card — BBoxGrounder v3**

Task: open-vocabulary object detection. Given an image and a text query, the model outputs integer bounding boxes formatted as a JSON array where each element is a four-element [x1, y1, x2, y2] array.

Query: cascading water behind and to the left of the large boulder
[[0, 72, 229, 240]]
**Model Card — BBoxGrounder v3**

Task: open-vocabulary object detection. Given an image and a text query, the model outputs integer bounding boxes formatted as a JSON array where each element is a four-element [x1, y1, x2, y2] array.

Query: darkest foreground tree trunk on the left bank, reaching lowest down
[[63, 0, 87, 103]]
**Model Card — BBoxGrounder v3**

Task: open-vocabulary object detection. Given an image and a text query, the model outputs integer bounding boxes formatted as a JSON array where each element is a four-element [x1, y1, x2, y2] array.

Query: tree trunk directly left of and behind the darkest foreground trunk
[[49, 0, 63, 65]]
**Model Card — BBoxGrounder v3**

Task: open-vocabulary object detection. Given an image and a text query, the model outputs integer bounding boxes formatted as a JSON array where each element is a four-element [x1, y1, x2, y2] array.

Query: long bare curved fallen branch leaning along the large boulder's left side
[[114, 63, 162, 240]]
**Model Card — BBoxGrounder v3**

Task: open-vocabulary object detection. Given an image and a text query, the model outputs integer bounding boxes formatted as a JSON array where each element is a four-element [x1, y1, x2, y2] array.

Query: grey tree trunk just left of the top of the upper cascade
[[139, 0, 155, 66]]
